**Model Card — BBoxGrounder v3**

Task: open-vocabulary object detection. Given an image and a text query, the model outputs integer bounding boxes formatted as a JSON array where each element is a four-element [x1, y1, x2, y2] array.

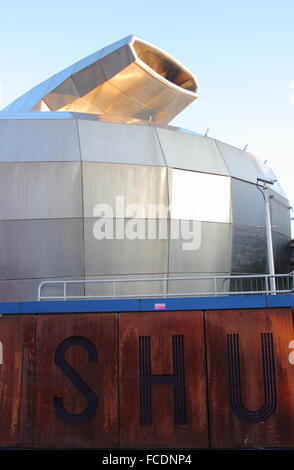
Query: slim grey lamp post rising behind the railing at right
[[257, 178, 277, 294]]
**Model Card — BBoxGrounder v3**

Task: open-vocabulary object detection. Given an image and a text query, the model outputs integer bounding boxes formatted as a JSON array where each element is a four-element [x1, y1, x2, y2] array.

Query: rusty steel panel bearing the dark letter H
[[120, 312, 208, 448]]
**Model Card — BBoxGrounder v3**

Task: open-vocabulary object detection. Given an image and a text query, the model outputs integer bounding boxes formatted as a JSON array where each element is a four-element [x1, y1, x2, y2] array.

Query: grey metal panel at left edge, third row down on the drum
[[0, 219, 84, 279]]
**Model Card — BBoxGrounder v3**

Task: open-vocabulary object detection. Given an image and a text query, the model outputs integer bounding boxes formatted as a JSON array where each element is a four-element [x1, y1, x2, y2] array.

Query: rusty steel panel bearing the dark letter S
[[34, 314, 118, 448]]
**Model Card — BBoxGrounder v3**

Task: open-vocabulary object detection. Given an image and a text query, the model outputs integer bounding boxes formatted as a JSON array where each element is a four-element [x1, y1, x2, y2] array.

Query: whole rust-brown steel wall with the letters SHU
[[0, 308, 294, 448]]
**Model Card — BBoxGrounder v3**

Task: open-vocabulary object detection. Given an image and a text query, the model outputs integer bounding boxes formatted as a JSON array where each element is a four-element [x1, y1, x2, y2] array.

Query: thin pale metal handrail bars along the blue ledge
[[38, 271, 294, 301]]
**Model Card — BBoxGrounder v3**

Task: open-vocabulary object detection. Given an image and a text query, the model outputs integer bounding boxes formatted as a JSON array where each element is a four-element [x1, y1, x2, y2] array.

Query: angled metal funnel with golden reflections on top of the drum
[[5, 36, 198, 123]]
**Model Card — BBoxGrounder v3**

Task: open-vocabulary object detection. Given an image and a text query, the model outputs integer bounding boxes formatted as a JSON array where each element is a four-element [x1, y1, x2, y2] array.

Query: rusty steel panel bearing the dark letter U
[[206, 309, 294, 448]]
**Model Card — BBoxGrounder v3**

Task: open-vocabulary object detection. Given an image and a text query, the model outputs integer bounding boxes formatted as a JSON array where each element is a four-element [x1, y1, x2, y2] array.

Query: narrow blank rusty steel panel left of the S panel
[[0, 316, 35, 447]]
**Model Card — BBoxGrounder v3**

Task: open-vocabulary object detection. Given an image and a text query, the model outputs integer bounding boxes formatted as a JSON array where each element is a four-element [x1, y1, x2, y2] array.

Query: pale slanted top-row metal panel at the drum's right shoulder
[[215, 140, 264, 183]]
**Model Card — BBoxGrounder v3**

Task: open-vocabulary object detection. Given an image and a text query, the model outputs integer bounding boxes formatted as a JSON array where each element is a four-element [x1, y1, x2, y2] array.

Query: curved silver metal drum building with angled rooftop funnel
[[0, 36, 290, 301]]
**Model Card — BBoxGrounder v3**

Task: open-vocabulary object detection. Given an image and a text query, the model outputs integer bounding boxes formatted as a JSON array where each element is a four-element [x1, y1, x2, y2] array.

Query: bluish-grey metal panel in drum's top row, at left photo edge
[[0, 119, 80, 162]]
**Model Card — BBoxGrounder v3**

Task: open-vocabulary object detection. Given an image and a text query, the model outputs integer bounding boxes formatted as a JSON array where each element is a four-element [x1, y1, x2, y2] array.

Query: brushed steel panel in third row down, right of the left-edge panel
[[84, 218, 168, 276]]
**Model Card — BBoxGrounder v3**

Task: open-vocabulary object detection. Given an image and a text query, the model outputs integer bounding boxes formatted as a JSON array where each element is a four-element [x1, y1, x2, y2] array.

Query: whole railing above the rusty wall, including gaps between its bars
[[38, 271, 294, 301]]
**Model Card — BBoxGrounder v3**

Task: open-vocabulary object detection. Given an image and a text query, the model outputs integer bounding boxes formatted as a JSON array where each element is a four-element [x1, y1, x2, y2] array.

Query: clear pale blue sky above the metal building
[[0, 0, 294, 231]]
